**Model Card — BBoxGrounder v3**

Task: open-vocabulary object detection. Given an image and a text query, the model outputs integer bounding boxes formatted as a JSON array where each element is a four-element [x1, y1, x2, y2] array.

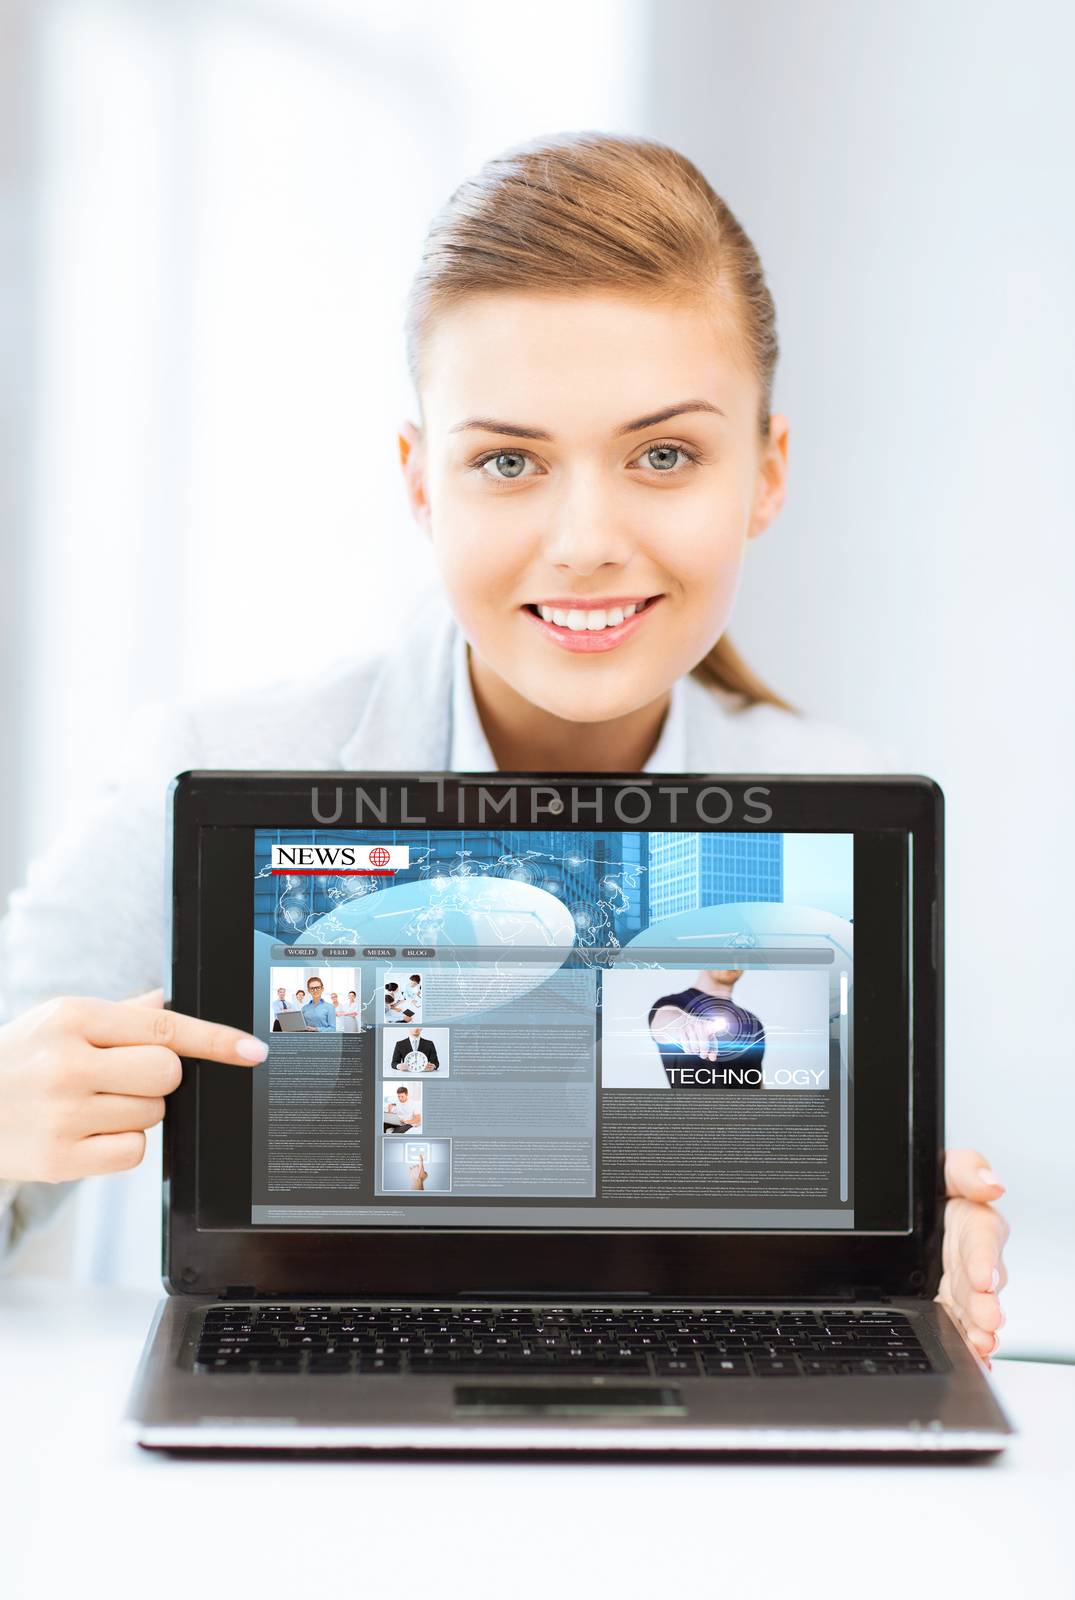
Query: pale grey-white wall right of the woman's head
[[648, 0, 1075, 1352]]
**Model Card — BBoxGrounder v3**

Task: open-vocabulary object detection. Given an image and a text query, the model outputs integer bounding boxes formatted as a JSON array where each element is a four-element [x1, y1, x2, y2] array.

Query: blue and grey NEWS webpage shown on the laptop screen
[[251, 827, 854, 1229]]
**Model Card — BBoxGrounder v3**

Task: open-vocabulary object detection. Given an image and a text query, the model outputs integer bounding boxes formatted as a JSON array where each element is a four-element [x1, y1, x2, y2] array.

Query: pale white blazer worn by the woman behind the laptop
[[0, 582, 901, 1254]]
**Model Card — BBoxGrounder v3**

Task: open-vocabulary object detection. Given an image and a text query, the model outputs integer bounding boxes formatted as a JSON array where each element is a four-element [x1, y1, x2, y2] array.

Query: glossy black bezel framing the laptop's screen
[[163, 771, 944, 1298]]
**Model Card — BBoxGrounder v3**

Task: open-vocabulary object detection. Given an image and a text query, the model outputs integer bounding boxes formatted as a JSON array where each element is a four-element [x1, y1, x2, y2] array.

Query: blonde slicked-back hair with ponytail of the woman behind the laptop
[[405, 133, 798, 714]]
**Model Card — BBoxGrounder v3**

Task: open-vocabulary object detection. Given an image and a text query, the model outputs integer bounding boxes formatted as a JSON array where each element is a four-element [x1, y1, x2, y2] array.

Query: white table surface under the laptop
[[0, 1278, 1075, 1600]]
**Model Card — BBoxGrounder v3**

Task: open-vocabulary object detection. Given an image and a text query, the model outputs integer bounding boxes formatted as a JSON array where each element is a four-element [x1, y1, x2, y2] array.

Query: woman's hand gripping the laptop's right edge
[[937, 1150, 1008, 1365]]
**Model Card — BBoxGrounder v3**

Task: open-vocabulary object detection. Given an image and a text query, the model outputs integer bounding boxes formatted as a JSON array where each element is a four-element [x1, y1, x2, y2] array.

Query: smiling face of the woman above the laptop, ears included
[[400, 293, 787, 722]]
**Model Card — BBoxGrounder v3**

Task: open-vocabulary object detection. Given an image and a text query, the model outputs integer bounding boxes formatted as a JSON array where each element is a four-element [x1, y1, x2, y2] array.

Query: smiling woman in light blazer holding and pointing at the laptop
[[0, 133, 1006, 1357]]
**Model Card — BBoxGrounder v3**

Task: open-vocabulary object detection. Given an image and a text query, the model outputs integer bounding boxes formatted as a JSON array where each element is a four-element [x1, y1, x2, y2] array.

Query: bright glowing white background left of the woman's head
[[0, 0, 645, 1283]]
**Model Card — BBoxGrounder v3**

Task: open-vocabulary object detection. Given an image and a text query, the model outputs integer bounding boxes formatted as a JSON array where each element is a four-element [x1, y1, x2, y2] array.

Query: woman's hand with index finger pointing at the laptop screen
[[0, 989, 267, 1184]]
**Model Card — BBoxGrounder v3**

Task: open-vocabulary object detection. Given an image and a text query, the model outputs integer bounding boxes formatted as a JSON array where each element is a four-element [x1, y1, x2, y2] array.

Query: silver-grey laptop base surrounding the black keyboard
[[125, 1296, 1014, 1456]]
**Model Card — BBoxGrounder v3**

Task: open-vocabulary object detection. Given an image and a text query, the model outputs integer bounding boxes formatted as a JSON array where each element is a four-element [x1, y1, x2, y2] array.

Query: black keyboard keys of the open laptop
[[195, 1304, 933, 1378]]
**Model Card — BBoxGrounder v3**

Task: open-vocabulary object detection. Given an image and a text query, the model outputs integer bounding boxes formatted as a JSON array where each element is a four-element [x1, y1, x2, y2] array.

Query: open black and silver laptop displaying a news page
[[126, 771, 1013, 1453]]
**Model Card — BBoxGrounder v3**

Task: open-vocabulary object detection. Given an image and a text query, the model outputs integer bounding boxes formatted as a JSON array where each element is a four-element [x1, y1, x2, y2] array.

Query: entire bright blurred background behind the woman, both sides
[[0, 0, 1075, 1350]]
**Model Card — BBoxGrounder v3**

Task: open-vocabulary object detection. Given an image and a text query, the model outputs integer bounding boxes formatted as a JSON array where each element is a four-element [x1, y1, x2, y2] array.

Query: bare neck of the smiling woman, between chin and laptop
[[467, 646, 672, 773]]
